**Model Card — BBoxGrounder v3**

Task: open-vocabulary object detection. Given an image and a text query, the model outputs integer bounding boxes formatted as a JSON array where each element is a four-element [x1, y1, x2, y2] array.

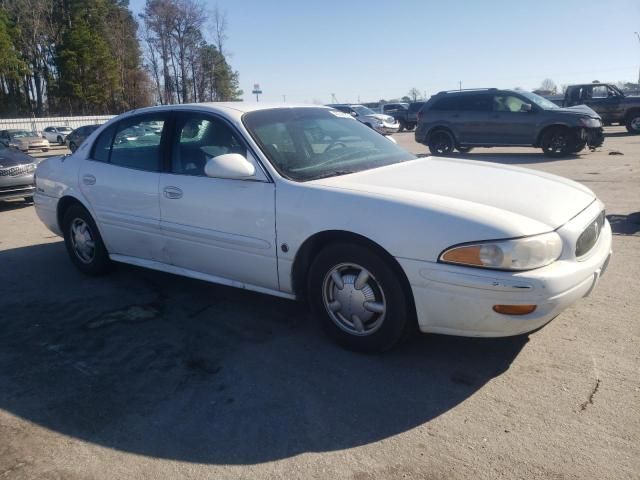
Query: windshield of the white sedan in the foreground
[[243, 108, 416, 182]]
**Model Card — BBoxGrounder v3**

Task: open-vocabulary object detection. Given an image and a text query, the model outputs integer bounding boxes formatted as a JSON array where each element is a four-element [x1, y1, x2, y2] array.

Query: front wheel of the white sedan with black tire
[[307, 243, 413, 353]]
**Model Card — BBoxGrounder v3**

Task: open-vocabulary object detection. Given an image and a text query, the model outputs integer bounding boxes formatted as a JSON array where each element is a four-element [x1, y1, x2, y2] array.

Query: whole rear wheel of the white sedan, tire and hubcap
[[62, 205, 111, 275]]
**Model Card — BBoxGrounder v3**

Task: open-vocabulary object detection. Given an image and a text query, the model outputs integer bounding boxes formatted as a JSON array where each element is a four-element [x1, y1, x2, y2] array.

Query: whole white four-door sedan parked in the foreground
[[34, 103, 611, 351]]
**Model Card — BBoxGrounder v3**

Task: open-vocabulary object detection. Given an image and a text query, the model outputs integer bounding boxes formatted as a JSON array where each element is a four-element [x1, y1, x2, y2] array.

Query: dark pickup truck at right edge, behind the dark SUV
[[550, 83, 640, 134]]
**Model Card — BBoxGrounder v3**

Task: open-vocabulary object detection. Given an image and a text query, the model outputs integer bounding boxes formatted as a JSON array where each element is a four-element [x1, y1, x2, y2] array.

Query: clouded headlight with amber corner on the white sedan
[[439, 232, 562, 270]]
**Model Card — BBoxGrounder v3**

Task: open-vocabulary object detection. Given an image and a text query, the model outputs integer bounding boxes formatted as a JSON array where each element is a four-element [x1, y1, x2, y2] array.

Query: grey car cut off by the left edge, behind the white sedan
[[0, 144, 37, 200]]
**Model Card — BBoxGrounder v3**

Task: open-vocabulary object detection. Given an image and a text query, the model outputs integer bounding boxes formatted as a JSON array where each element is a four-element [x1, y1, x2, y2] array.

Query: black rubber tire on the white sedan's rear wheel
[[62, 204, 111, 275]]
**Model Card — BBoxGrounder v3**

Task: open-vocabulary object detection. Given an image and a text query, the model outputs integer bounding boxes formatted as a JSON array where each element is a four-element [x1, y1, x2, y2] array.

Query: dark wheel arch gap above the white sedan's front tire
[[291, 230, 416, 317]]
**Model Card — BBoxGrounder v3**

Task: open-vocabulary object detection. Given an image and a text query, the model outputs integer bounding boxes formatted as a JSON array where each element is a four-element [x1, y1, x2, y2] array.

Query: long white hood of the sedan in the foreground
[[312, 157, 596, 235]]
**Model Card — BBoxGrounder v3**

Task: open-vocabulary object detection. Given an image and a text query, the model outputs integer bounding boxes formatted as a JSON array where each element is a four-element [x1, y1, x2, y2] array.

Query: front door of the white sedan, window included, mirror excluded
[[160, 112, 278, 289]]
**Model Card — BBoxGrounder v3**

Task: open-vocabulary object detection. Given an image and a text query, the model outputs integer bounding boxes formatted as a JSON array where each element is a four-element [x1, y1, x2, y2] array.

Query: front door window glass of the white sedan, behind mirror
[[171, 113, 247, 177]]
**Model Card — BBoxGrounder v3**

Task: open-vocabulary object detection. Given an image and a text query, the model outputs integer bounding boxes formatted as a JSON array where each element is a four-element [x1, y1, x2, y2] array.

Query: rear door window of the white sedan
[[110, 115, 165, 172]]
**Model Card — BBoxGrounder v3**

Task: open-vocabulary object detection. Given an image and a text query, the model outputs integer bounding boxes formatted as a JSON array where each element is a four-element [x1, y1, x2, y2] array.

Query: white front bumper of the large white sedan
[[398, 202, 612, 337]]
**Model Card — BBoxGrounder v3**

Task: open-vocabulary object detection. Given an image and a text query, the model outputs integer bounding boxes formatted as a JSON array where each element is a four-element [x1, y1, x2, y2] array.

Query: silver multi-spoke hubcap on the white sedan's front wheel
[[322, 263, 387, 336]]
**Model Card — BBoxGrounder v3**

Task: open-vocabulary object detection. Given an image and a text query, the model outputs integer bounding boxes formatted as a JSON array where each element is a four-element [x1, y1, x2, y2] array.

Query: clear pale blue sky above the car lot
[[131, 0, 640, 103]]
